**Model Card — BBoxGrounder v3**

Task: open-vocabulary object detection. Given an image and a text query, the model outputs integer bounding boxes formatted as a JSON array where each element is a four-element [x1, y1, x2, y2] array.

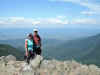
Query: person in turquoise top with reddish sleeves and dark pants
[[25, 33, 35, 64]]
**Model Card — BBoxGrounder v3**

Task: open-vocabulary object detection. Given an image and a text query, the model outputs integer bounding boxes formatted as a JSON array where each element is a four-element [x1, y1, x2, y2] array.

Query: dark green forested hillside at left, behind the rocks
[[0, 44, 24, 60]]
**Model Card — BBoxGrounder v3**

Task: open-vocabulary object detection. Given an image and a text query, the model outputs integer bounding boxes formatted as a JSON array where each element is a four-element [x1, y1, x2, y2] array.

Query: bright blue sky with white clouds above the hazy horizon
[[0, 0, 100, 28]]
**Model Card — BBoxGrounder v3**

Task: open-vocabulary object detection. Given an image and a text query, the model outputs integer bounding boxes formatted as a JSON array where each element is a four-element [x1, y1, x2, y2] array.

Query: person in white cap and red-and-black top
[[33, 29, 42, 55]]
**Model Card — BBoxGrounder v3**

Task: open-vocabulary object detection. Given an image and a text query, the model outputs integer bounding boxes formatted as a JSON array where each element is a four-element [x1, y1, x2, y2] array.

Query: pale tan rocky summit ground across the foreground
[[0, 55, 100, 75]]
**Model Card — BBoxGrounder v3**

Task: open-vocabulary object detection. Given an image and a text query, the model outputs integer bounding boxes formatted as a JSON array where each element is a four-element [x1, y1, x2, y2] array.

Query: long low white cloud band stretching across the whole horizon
[[0, 16, 100, 28]]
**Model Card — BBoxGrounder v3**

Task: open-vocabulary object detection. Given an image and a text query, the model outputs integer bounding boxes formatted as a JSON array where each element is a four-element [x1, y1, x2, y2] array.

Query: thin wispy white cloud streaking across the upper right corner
[[49, 0, 100, 15]]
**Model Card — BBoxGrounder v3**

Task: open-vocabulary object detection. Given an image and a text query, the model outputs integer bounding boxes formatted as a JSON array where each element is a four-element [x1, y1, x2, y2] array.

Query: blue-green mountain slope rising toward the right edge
[[44, 34, 100, 65]]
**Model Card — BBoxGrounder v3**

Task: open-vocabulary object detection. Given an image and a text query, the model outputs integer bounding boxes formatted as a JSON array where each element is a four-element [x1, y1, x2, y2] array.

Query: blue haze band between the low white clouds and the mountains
[[0, 28, 100, 40]]
